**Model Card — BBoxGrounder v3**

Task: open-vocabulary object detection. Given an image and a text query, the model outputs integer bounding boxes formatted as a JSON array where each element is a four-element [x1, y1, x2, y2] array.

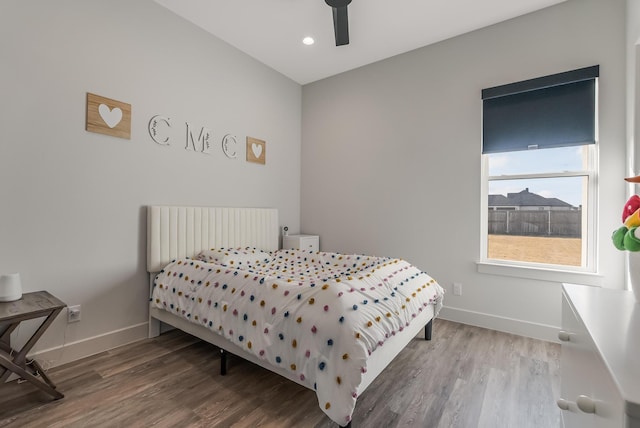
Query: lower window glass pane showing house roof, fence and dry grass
[[487, 177, 588, 266]]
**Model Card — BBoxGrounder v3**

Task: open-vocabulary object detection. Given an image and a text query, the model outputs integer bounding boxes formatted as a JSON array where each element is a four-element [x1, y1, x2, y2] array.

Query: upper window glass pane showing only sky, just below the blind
[[486, 146, 588, 176]]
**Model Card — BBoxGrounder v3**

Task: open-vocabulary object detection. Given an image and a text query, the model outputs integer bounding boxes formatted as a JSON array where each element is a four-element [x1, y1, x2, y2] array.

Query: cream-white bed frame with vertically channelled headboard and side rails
[[147, 206, 434, 422]]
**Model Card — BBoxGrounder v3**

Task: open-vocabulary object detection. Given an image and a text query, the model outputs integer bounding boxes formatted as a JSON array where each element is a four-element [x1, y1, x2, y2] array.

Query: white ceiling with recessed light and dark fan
[[155, 0, 565, 84]]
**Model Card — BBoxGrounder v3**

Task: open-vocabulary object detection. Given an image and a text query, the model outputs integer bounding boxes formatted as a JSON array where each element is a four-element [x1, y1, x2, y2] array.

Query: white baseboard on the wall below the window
[[433, 306, 560, 343]]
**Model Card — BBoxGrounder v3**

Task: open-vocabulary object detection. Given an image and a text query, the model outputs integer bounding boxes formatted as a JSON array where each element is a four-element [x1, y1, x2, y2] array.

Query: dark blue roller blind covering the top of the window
[[482, 65, 600, 153]]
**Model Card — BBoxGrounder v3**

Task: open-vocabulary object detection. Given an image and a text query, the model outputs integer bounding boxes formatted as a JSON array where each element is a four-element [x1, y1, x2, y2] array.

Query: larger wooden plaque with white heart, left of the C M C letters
[[86, 92, 131, 140]]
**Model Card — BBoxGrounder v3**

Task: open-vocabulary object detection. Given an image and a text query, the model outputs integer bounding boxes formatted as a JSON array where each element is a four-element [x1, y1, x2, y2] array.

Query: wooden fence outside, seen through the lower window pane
[[488, 210, 582, 238]]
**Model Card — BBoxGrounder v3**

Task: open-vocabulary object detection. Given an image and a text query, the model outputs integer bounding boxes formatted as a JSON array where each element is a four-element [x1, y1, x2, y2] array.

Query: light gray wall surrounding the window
[[301, 0, 626, 339]]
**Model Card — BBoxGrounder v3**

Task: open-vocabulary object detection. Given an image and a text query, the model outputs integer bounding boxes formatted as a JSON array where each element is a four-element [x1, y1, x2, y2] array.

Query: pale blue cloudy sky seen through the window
[[489, 146, 586, 206]]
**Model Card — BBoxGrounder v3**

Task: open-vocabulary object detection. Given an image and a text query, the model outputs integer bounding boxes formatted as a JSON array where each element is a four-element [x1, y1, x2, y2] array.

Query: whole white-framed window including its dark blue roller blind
[[481, 66, 599, 272]]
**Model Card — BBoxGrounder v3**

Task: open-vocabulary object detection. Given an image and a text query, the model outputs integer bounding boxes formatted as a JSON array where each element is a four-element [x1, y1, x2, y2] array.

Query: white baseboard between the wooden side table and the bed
[[29, 322, 149, 370]]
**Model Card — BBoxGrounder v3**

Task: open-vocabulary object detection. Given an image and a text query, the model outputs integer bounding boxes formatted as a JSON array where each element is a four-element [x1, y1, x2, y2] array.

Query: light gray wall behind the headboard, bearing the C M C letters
[[0, 0, 301, 364]]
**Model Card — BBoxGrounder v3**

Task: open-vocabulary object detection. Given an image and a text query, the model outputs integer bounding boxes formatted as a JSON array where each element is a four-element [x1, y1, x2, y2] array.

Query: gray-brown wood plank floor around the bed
[[0, 320, 560, 428]]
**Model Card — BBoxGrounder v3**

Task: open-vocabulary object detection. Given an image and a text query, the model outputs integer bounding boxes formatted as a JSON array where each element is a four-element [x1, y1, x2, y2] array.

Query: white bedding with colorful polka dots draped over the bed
[[151, 248, 444, 425]]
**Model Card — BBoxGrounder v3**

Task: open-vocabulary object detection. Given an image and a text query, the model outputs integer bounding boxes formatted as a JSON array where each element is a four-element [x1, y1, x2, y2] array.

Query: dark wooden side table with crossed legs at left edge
[[0, 291, 67, 399]]
